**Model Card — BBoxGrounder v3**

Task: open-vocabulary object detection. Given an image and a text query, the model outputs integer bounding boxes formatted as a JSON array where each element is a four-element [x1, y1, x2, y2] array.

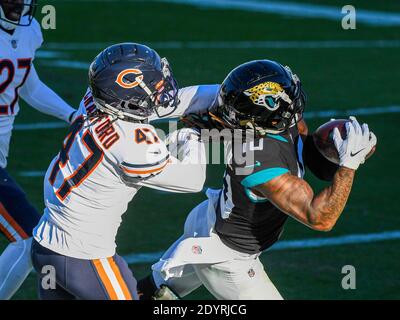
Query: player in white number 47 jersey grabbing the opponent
[[32, 43, 217, 300]]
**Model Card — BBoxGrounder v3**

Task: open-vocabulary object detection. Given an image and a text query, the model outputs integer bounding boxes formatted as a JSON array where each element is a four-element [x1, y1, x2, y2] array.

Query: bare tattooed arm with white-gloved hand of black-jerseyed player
[[254, 118, 376, 231]]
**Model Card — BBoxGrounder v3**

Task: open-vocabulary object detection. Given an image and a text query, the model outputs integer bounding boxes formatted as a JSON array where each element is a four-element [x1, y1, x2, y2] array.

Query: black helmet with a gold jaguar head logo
[[210, 60, 306, 136]]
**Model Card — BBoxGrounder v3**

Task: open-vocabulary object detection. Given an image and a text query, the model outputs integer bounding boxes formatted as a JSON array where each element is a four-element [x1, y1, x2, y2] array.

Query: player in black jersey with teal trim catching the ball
[[138, 60, 376, 300]]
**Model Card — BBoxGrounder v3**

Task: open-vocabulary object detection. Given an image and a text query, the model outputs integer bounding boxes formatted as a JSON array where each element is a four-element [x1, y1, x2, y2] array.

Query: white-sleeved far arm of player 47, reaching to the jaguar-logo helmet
[[149, 84, 220, 121]]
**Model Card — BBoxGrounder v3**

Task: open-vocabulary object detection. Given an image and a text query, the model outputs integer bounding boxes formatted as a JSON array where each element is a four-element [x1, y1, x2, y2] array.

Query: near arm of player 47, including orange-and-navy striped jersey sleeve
[[119, 126, 206, 193]]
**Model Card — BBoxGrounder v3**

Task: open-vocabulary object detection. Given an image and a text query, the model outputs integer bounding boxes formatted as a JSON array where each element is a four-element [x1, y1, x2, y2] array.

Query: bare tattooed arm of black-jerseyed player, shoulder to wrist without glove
[[254, 167, 355, 231]]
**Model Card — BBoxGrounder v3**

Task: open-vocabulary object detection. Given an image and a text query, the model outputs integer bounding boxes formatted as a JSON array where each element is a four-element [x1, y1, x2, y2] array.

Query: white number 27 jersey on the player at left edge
[[0, 17, 43, 168]]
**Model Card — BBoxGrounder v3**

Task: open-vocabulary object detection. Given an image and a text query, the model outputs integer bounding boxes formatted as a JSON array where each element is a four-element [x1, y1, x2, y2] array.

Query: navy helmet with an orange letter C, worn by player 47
[[89, 43, 178, 122]]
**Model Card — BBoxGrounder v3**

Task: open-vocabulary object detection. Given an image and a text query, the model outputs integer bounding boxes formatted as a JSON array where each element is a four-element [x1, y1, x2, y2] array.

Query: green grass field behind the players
[[0, 0, 400, 299]]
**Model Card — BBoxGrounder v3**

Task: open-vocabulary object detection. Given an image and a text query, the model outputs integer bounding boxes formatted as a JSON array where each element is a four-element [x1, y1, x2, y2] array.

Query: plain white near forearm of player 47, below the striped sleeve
[[140, 140, 206, 193]]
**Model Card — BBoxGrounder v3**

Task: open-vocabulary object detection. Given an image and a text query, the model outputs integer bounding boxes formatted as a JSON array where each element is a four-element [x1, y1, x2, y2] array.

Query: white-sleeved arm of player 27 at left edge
[[20, 65, 76, 122]]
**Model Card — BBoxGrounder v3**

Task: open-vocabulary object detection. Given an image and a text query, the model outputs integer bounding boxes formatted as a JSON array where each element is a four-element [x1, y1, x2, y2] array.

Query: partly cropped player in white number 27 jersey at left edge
[[0, 0, 76, 299]]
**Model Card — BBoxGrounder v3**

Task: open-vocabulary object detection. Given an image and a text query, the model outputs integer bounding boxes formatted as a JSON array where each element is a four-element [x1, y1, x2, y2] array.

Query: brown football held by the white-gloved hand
[[313, 119, 376, 164]]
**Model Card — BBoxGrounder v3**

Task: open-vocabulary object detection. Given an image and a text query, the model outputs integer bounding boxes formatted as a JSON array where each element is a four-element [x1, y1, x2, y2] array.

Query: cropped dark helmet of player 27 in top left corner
[[0, 0, 37, 30]]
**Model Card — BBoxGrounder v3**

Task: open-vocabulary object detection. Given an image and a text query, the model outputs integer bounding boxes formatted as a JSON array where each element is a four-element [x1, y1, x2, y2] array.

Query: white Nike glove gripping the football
[[333, 117, 377, 170]]
